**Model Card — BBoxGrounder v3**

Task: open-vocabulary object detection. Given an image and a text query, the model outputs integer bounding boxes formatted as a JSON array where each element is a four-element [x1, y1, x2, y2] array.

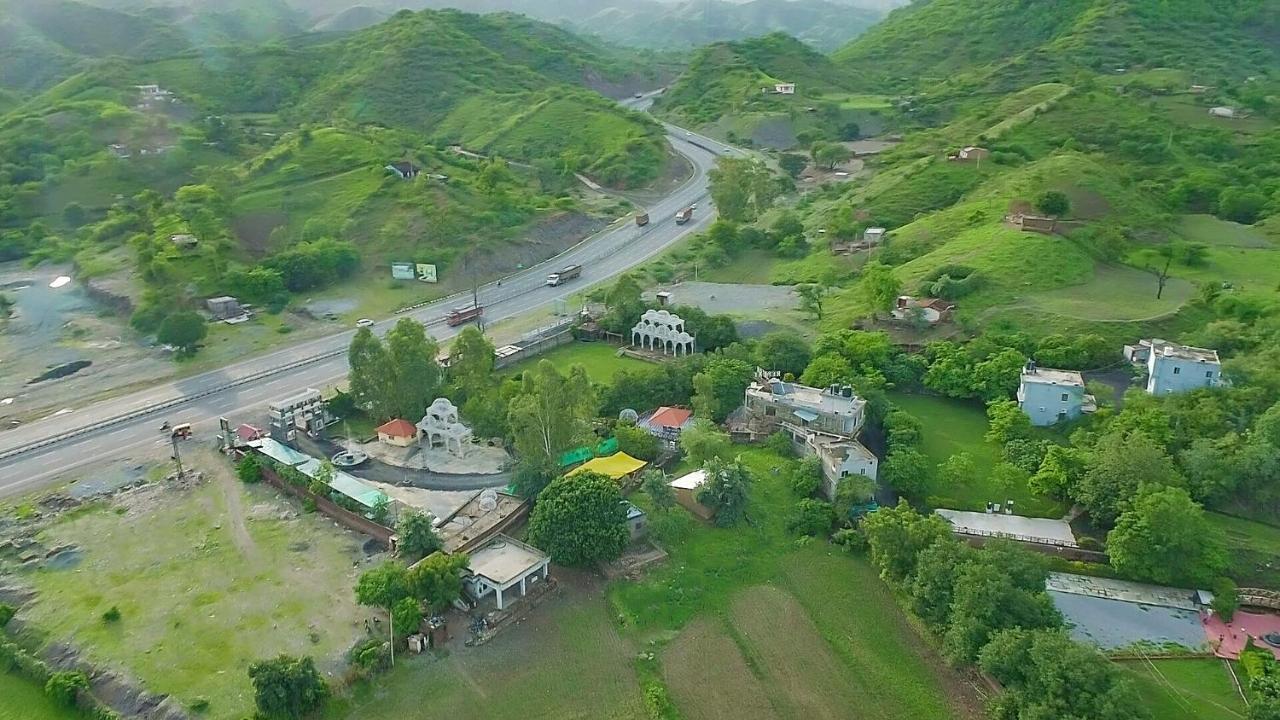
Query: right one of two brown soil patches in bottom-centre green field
[[732, 587, 865, 720]]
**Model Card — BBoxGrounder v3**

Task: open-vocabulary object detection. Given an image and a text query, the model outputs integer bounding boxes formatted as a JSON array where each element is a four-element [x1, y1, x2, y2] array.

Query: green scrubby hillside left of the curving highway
[[0, 6, 669, 345]]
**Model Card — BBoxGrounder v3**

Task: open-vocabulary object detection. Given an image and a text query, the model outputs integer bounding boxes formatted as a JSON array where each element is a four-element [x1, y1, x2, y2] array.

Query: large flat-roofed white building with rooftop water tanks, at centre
[[731, 369, 878, 498]]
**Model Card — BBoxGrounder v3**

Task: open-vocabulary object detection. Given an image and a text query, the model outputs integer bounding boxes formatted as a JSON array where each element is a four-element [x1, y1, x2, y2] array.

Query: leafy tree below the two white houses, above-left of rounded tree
[[1073, 430, 1183, 525]]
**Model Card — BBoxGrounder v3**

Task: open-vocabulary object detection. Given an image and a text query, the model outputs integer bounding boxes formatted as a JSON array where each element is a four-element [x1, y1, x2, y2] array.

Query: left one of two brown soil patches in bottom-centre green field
[[662, 620, 778, 720]]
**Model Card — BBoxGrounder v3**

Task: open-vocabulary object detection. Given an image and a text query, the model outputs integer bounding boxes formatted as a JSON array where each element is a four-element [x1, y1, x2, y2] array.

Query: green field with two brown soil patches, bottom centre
[[609, 448, 974, 720]]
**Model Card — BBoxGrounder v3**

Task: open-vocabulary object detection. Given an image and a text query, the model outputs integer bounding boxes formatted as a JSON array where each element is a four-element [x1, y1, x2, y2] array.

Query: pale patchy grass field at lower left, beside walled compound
[[22, 455, 366, 720]]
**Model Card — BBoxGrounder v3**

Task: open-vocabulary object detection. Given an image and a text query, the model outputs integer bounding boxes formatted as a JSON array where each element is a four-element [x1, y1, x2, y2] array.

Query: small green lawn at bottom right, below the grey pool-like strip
[[1119, 659, 1245, 720]]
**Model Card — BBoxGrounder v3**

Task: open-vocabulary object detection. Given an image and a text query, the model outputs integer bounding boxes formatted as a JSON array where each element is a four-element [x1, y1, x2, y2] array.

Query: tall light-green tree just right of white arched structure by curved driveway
[[507, 360, 595, 464]]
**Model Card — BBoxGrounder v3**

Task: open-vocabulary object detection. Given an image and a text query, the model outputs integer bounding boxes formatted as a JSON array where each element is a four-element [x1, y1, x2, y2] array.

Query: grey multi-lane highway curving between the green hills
[[0, 119, 735, 497]]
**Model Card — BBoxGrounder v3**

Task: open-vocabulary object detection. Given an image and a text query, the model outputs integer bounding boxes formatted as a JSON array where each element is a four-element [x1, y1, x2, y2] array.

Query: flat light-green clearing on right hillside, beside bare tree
[[1027, 265, 1196, 323]]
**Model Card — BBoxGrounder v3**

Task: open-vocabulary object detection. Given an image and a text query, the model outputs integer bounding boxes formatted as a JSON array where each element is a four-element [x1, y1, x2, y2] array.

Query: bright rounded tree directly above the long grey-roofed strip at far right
[[1107, 486, 1226, 585]]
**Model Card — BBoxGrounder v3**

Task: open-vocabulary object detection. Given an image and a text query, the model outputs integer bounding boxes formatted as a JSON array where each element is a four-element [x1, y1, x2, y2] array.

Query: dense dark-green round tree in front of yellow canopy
[[529, 473, 627, 566]]
